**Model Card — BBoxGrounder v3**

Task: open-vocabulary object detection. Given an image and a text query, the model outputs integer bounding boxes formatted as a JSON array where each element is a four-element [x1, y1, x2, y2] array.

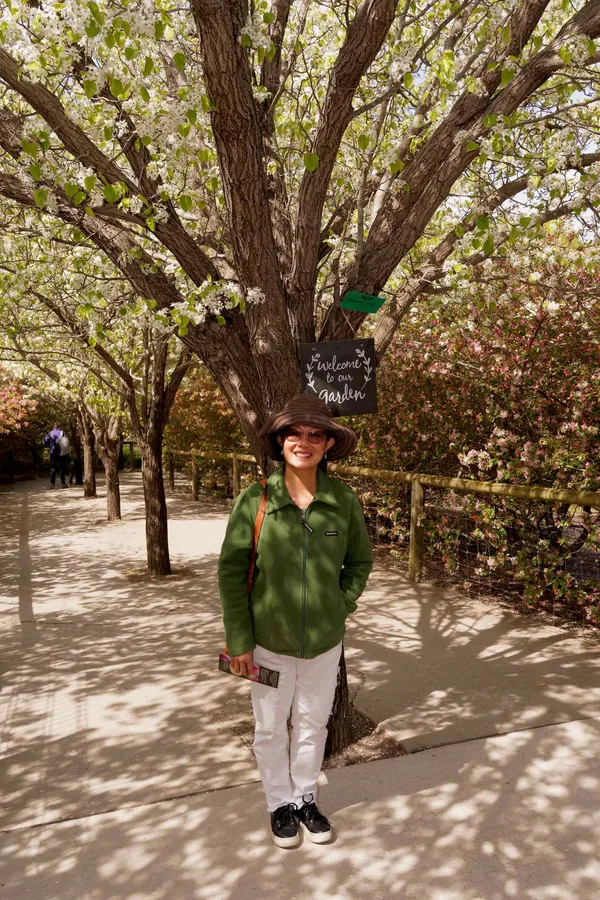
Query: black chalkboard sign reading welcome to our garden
[[300, 338, 377, 416]]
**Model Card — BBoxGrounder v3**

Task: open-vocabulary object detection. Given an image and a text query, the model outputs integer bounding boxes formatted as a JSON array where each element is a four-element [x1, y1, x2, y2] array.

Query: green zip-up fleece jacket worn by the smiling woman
[[219, 469, 373, 659]]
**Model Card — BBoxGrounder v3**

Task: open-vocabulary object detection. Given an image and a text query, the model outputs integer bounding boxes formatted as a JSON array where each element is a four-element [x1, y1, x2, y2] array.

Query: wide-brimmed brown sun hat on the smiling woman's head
[[259, 394, 358, 460]]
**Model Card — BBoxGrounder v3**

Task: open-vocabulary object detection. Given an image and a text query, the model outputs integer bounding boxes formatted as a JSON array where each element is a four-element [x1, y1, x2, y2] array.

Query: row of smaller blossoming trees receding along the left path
[[0, 274, 192, 576]]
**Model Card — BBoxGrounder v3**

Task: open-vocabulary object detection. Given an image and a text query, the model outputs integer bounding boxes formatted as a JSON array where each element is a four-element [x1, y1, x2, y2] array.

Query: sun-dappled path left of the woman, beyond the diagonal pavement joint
[[0, 475, 257, 827]]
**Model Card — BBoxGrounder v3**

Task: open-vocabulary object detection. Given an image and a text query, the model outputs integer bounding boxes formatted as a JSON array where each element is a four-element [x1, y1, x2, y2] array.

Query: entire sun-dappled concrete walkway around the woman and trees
[[0, 475, 600, 900]]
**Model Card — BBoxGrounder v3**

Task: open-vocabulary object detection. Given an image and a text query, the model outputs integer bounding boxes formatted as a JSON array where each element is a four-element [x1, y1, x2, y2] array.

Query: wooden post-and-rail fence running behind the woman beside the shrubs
[[166, 450, 600, 581]]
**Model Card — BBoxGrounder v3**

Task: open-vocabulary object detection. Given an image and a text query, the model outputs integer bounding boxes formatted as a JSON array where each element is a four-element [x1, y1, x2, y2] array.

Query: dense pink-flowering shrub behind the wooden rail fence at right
[[346, 248, 600, 620]]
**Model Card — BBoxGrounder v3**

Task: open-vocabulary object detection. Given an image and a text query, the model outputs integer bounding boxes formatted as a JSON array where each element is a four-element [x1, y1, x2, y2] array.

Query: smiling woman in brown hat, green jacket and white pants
[[219, 395, 373, 847]]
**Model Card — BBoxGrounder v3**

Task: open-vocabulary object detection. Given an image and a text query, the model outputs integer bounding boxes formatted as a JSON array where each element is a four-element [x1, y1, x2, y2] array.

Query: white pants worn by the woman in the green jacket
[[252, 643, 342, 812]]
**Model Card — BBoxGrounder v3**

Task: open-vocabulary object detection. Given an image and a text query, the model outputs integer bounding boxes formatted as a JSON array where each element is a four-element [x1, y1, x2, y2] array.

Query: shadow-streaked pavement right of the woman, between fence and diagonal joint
[[347, 571, 600, 750]]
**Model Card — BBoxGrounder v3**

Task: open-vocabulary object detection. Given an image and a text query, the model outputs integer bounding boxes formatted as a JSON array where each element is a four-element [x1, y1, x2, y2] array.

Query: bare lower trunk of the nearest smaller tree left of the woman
[[140, 439, 171, 577]]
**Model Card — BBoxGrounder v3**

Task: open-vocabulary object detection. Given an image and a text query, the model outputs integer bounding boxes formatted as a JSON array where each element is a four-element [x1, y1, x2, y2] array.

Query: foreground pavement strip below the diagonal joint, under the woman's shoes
[[3, 722, 600, 900]]
